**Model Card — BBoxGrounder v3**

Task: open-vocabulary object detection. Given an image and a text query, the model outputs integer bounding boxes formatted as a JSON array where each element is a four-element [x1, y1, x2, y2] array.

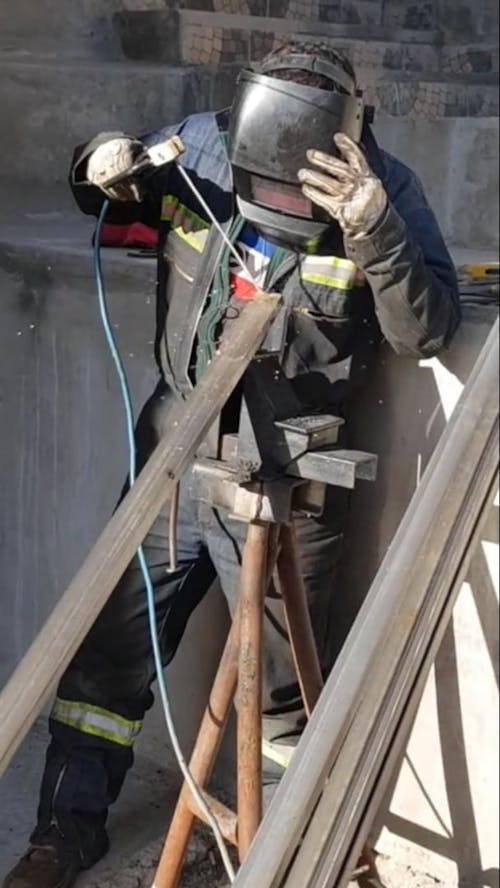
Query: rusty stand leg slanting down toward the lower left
[[154, 611, 239, 888]]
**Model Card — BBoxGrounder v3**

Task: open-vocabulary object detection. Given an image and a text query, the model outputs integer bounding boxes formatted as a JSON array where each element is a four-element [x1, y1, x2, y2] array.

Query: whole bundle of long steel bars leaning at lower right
[[235, 321, 499, 888]]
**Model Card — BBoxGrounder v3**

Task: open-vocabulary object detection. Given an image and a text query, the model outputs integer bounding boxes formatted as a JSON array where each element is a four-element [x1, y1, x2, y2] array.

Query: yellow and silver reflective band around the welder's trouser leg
[[50, 697, 142, 747]]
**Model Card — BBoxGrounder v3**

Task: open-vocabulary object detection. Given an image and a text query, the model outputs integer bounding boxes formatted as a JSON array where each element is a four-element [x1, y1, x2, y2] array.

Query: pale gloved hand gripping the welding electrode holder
[[87, 136, 144, 203]]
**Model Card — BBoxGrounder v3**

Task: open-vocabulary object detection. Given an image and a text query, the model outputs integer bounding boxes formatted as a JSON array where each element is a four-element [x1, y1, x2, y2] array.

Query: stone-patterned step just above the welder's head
[[114, 9, 498, 78]]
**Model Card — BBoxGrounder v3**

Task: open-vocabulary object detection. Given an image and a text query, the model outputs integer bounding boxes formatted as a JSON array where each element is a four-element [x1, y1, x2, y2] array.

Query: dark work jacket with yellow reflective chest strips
[[71, 106, 460, 412]]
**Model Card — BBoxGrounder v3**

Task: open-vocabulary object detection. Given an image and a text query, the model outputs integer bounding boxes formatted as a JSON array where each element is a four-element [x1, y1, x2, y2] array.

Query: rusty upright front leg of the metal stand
[[237, 523, 269, 860]]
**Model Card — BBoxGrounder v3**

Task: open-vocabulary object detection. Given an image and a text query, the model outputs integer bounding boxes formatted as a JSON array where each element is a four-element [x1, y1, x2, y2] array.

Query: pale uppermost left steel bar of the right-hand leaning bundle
[[236, 322, 498, 888]]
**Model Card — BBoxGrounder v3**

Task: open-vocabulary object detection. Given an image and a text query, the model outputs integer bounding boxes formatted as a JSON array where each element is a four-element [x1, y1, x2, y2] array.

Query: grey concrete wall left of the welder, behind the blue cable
[[0, 226, 232, 765]]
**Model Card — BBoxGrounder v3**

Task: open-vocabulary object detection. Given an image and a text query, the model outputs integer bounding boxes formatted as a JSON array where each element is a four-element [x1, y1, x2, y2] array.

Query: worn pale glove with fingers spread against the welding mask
[[299, 133, 388, 238]]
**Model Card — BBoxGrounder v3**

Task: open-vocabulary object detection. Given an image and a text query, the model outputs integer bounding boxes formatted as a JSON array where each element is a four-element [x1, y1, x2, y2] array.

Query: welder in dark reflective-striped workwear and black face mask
[[3, 41, 460, 888]]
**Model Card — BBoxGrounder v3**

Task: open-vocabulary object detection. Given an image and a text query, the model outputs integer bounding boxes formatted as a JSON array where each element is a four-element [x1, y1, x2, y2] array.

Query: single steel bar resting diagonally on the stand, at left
[[0, 293, 280, 775]]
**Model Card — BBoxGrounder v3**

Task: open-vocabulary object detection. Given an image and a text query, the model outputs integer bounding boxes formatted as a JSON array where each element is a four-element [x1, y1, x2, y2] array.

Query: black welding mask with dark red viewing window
[[228, 55, 366, 252]]
